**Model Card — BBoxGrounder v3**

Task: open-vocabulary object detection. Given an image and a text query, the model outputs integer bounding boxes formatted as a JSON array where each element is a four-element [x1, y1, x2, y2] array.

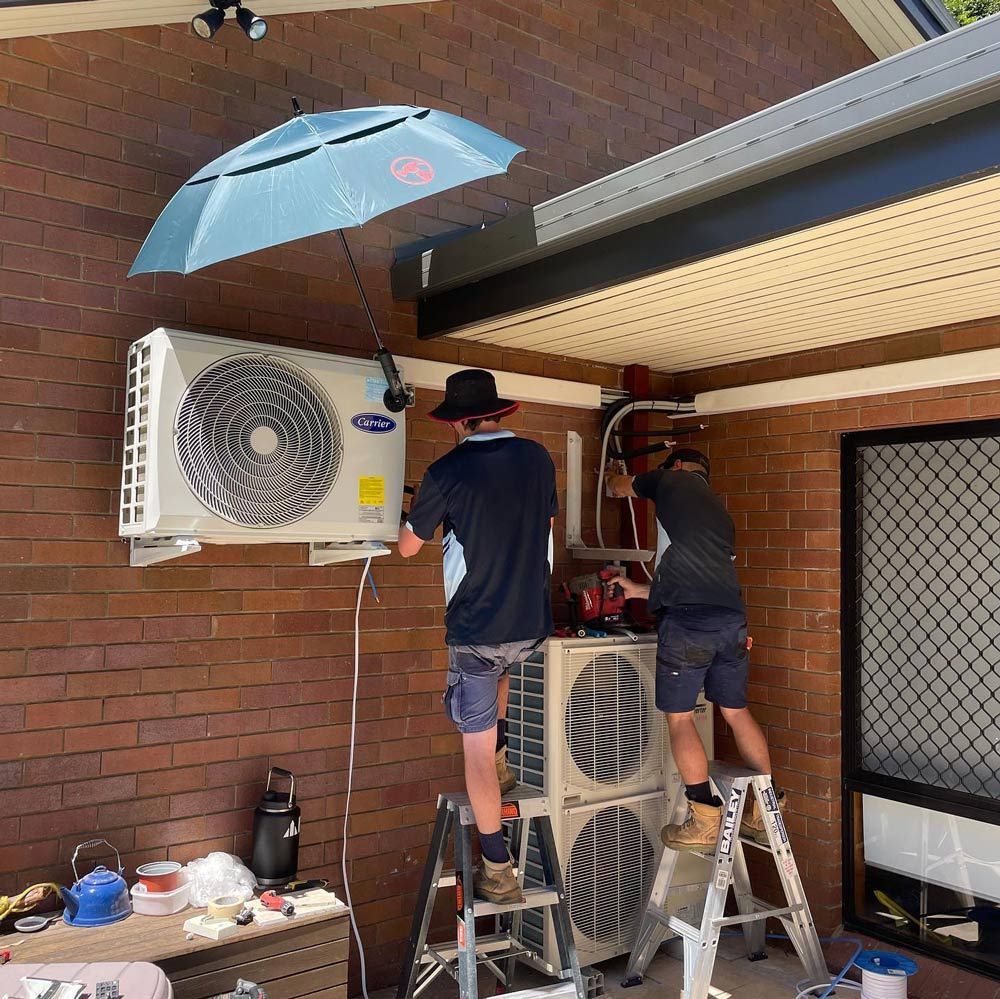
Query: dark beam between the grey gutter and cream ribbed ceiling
[[418, 101, 1000, 339]]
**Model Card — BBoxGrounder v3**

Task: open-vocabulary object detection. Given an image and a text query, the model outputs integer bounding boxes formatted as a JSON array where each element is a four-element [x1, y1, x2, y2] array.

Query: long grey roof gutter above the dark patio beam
[[392, 15, 1000, 320]]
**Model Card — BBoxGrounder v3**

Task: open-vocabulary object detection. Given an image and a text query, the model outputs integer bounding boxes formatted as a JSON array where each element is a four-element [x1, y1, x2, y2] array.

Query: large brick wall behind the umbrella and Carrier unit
[[0, 0, 872, 984]]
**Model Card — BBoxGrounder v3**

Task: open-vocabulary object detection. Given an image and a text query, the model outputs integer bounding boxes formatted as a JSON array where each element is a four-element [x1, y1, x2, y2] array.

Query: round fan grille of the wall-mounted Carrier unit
[[175, 354, 343, 528]]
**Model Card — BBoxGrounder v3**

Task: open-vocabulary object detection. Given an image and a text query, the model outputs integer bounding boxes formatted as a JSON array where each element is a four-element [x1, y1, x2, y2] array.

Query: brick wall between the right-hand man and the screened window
[[662, 321, 1000, 940]]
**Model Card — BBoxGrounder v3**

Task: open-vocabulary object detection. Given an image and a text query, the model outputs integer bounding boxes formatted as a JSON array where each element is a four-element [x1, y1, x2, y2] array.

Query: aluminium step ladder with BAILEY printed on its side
[[622, 762, 830, 999]]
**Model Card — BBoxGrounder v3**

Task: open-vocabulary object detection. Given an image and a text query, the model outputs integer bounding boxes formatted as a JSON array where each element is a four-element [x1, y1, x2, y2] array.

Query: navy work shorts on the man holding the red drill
[[656, 606, 750, 714]]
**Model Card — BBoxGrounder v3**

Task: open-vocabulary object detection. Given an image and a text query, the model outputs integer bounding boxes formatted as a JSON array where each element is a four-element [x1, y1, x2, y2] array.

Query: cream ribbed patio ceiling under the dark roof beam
[[454, 174, 1000, 372]]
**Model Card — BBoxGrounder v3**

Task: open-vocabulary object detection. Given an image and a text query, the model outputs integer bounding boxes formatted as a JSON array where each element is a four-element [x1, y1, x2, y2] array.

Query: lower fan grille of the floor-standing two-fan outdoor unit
[[562, 798, 662, 948]]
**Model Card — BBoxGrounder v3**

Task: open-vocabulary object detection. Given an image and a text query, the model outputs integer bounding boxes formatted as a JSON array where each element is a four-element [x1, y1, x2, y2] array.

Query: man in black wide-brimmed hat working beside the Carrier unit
[[399, 369, 559, 903]]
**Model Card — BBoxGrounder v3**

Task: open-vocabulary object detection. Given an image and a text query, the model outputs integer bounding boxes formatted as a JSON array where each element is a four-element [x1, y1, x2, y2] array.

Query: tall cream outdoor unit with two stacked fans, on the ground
[[507, 635, 713, 974]]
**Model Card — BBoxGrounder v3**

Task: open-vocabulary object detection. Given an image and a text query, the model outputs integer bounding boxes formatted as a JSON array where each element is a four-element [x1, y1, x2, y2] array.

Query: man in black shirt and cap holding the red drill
[[607, 448, 771, 850]]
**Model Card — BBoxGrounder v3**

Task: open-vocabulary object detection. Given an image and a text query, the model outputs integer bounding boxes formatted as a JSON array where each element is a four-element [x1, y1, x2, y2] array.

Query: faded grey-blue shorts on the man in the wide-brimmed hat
[[444, 639, 539, 735]]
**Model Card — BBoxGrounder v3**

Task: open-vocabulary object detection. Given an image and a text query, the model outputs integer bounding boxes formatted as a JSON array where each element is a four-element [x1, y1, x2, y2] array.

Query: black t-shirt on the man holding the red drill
[[633, 469, 746, 614]]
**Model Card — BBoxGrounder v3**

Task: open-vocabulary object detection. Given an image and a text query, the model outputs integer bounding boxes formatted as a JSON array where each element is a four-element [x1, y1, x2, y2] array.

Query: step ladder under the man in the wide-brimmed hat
[[396, 787, 587, 999]]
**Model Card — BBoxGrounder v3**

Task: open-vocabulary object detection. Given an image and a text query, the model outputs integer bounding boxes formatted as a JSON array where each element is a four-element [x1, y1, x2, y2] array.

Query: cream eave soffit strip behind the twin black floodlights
[[0, 0, 439, 44]]
